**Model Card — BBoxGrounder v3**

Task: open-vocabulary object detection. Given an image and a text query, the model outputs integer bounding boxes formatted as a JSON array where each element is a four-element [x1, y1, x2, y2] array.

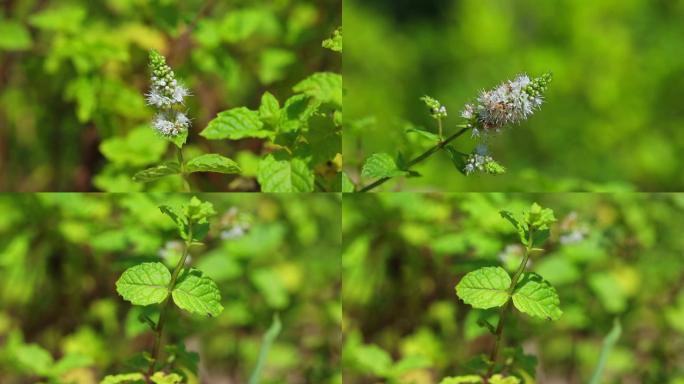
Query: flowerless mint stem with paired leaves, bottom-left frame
[[103, 197, 223, 383]]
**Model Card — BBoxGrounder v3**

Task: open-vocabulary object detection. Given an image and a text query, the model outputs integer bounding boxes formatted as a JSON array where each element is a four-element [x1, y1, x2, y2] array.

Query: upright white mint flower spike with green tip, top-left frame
[[145, 51, 190, 137]]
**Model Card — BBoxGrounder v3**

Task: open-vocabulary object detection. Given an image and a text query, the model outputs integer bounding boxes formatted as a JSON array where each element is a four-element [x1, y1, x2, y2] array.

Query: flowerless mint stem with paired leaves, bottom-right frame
[[441, 203, 563, 384]]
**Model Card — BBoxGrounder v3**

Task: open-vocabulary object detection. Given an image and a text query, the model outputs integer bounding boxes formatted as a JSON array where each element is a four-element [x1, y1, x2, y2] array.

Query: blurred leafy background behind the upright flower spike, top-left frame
[[0, 0, 342, 192]]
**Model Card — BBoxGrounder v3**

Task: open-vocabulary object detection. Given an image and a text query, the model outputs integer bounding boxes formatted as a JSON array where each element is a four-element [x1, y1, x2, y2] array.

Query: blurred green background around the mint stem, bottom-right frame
[[342, 193, 684, 384]]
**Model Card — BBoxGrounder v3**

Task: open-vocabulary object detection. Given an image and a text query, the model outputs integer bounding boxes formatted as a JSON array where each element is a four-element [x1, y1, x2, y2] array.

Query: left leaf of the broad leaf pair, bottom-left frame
[[116, 263, 171, 305]]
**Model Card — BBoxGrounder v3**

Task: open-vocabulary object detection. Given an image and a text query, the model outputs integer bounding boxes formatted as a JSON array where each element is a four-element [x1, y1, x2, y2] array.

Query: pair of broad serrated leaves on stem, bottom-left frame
[[116, 262, 223, 317]]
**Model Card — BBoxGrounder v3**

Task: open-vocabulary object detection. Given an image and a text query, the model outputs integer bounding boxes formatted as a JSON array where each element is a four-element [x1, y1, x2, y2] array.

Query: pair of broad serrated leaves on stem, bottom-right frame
[[456, 267, 563, 320]]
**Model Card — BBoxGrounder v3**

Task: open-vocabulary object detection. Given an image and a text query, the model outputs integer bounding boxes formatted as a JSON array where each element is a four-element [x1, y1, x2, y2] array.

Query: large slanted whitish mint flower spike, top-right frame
[[461, 73, 552, 137]]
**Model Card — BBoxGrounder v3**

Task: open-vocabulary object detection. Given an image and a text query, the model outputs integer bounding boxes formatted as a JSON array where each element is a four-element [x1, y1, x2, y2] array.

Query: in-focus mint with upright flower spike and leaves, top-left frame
[[133, 29, 342, 192]]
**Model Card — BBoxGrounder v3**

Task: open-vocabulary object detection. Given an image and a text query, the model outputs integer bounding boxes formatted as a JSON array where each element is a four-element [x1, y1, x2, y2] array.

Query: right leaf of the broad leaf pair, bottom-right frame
[[513, 273, 563, 320]]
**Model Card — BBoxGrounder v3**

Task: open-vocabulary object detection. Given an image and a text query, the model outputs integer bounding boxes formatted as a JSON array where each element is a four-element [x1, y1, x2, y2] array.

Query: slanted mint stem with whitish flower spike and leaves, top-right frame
[[352, 73, 551, 192]]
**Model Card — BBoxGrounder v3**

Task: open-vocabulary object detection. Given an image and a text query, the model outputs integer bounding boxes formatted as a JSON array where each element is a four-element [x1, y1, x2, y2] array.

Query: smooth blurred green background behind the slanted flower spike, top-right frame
[[343, 0, 684, 192]]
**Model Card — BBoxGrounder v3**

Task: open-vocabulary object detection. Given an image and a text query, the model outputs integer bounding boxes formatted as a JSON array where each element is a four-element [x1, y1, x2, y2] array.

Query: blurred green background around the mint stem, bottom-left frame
[[0, 194, 342, 384]]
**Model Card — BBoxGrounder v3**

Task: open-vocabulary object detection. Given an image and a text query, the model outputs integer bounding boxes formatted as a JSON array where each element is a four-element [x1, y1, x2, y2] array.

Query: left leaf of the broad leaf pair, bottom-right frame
[[456, 267, 511, 309]]
